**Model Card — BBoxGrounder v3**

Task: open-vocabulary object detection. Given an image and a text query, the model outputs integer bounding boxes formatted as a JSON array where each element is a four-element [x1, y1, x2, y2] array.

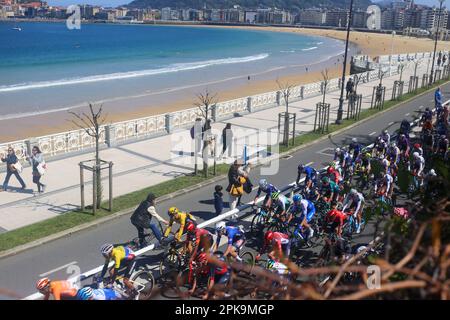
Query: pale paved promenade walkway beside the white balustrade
[[0, 61, 440, 233]]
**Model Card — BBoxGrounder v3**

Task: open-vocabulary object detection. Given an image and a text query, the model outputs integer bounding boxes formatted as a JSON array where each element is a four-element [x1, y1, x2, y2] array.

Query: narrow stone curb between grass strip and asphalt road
[[0, 81, 450, 259]]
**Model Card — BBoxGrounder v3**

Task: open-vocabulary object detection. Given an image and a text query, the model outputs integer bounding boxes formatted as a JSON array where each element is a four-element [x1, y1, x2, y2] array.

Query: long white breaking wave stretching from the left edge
[[0, 53, 269, 93]]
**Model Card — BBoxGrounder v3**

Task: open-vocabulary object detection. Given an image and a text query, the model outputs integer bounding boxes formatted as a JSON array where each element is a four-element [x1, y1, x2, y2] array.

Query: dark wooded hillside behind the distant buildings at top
[[128, 0, 371, 11]]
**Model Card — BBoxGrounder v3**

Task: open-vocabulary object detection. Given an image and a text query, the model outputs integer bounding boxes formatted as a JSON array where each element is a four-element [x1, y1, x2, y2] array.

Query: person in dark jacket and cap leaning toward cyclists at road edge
[[130, 193, 169, 247]]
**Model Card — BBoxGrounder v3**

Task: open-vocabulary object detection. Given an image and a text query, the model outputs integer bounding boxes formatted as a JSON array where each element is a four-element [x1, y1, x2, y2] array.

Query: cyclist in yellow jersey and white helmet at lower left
[[100, 243, 135, 292]]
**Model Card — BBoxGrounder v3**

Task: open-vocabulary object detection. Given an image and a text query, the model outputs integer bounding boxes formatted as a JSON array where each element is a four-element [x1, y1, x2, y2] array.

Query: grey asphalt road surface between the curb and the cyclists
[[0, 84, 450, 298]]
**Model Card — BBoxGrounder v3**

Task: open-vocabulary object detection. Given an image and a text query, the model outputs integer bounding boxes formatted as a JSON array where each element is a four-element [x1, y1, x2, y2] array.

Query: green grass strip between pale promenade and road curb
[[0, 76, 448, 252]]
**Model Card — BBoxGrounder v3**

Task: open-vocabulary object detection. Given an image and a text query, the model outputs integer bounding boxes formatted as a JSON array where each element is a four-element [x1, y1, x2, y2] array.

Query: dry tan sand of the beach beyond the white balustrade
[[0, 26, 450, 142]]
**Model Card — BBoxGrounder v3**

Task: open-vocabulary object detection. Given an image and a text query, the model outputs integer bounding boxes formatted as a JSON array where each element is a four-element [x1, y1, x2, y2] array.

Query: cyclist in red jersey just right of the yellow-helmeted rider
[[185, 221, 214, 261]]
